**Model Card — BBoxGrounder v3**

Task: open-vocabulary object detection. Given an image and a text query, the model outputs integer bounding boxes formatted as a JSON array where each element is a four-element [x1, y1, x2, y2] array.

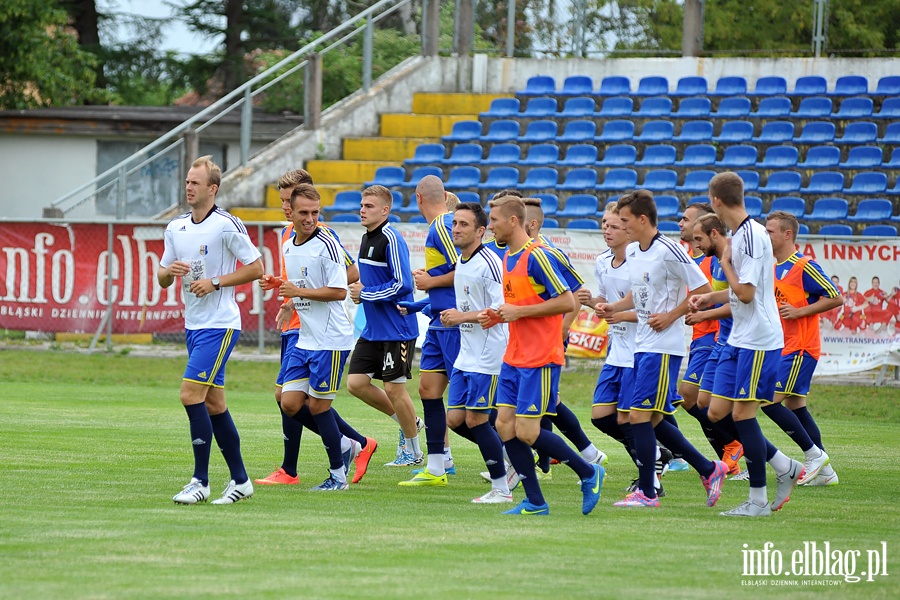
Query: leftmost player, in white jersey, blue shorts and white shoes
[[156, 156, 263, 504]]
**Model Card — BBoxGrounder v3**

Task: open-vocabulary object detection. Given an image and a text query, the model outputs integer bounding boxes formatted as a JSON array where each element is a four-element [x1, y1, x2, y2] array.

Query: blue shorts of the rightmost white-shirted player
[[712, 344, 781, 402]]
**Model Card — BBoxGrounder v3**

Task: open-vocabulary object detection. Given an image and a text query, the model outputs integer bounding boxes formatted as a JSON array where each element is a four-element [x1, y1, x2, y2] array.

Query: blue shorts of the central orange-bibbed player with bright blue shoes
[[497, 363, 562, 418]]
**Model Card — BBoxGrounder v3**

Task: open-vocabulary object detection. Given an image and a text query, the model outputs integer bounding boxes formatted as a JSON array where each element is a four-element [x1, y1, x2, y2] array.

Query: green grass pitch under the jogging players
[[0, 350, 900, 599]]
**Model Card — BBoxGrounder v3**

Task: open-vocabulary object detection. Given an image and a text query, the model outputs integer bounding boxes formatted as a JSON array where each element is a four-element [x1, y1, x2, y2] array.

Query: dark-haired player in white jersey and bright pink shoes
[[597, 190, 728, 507]]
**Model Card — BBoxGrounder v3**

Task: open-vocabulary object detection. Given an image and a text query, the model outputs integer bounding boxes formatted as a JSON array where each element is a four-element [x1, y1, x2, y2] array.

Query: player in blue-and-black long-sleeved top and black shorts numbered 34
[[347, 185, 424, 466]]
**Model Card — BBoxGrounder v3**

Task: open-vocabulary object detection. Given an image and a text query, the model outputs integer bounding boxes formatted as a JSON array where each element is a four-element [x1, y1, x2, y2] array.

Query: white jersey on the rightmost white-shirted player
[[728, 217, 784, 350]]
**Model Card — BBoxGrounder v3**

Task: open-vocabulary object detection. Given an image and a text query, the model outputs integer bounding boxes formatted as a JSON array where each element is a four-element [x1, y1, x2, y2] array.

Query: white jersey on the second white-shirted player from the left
[[281, 227, 353, 350]]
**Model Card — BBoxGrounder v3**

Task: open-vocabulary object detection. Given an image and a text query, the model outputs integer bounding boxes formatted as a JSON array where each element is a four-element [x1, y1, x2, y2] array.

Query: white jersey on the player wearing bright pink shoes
[[625, 233, 709, 356]]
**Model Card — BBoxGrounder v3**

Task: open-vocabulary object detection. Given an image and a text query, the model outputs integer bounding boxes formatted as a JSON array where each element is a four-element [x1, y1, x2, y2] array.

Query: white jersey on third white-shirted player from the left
[[453, 246, 509, 375]]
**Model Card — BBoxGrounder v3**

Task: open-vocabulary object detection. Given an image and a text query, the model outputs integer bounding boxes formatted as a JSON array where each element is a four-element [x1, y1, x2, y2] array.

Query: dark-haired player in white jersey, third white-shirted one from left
[[440, 202, 513, 504]]
